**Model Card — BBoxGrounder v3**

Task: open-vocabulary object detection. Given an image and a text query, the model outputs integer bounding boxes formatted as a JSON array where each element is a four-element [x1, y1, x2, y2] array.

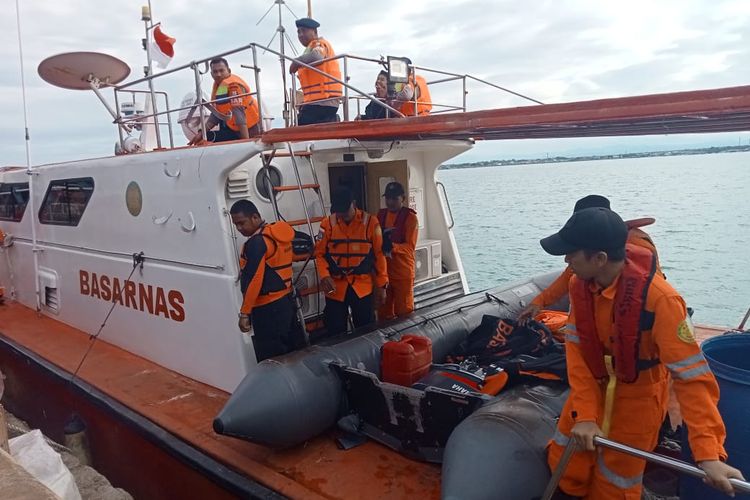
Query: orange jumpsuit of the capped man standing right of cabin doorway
[[378, 211, 419, 320]]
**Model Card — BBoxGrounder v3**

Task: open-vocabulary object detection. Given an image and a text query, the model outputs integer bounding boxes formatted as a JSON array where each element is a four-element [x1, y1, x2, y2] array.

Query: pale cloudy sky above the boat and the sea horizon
[[0, 0, 750, 165]]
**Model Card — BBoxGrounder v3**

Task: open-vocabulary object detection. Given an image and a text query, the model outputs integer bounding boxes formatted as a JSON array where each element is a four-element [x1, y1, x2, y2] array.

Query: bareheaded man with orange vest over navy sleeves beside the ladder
[[230, 200, 301, 361]]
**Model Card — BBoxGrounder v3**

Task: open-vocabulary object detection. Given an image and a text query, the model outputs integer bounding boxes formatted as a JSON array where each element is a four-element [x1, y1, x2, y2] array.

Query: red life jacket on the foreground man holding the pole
[[570, 244, 659, 383]]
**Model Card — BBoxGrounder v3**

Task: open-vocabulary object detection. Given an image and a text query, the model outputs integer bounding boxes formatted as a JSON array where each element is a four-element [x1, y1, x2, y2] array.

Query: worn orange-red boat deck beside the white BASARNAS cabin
[[0, 303, 440, 499]]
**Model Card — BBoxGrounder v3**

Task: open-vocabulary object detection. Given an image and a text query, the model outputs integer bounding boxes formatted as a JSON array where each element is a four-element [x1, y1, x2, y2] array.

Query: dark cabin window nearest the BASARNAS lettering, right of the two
[[39, 177, 94, 226]]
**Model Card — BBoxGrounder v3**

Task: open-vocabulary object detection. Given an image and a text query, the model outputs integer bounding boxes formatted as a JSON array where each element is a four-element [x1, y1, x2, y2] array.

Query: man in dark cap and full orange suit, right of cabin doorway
[[378, 182, 419, 321]]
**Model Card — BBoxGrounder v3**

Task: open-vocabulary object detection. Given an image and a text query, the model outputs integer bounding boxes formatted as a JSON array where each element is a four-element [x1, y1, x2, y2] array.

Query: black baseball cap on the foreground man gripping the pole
[[539, 207, 628, 255]]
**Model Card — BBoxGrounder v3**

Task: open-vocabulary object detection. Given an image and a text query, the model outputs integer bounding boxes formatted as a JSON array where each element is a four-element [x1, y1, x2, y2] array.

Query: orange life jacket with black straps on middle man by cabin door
[[324, 213, 375, 278]]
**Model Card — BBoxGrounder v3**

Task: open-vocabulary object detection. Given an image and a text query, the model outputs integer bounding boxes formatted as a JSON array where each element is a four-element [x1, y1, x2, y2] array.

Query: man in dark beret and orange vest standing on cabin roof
[[289, 17, 342, 125]]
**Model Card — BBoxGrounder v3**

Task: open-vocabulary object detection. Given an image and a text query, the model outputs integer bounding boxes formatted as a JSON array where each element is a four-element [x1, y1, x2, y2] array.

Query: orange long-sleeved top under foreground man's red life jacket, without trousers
[[565, 274, 727, 462]]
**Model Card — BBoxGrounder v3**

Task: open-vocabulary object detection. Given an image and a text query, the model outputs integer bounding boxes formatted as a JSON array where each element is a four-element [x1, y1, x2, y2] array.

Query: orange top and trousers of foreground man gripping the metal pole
[[548, 273, 727, 500]]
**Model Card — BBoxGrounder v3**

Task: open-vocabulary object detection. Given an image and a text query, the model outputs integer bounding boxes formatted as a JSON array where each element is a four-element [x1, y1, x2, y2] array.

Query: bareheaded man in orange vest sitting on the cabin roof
[[188, 57, 260, 145]]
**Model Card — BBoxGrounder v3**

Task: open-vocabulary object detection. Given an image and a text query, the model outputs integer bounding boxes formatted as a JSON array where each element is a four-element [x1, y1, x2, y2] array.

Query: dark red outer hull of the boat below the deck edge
[[0, 336, 284, 499]]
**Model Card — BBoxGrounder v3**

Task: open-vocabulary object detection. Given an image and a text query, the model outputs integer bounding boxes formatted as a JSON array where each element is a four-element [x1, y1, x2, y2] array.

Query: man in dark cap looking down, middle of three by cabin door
[[315, 187, 388, 334]]
